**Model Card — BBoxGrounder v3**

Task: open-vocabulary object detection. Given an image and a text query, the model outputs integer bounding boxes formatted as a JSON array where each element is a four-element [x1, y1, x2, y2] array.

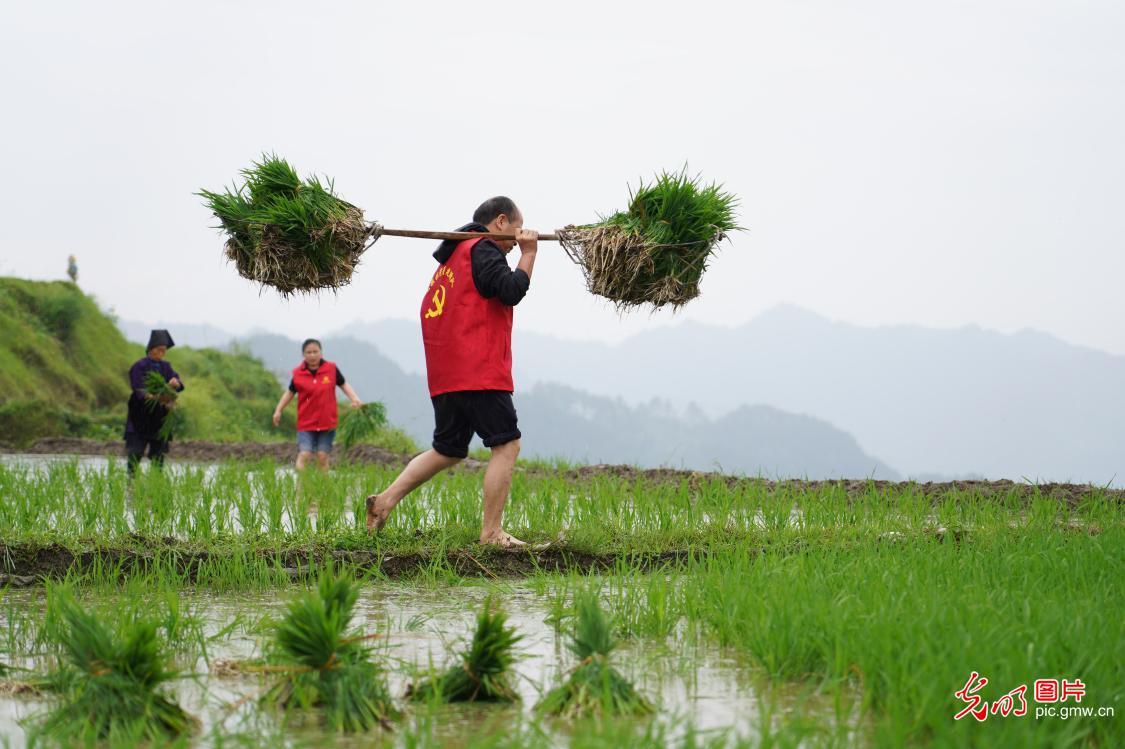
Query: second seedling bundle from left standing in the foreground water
[[264, 574, 397, 731]]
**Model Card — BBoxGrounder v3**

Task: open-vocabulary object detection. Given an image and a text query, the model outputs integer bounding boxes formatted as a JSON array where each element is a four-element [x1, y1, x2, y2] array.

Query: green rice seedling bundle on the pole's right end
[[558, 171, 739, 309]]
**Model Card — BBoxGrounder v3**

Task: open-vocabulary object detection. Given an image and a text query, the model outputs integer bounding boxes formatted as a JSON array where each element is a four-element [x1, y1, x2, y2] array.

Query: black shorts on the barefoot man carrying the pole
[[430, 390, 520, 458]]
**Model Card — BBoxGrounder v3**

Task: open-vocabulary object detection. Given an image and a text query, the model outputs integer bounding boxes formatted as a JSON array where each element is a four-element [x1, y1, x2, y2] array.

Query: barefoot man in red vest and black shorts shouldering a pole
[[367, 197, 539, 548]]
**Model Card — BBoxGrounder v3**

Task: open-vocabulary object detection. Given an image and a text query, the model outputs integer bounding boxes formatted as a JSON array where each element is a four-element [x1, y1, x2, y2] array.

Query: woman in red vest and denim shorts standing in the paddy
[[273, 339, 363, 470]]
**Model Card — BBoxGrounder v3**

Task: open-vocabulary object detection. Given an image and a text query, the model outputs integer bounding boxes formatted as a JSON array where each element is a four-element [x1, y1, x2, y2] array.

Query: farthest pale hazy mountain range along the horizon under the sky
[[347, 306, 1125, 484]]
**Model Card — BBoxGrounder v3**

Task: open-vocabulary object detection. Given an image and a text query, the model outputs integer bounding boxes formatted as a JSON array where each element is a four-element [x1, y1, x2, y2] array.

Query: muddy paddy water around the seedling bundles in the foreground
[[0, 584, 846, 747]]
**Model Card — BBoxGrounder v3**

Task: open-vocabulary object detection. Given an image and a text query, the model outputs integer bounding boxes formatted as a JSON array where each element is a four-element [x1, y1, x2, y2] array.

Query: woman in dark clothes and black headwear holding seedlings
[[125, 331, 183, 476]]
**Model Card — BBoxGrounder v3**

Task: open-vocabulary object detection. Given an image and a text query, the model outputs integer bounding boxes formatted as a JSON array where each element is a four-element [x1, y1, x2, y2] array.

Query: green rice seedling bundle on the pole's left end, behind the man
[[198, 154, 368, 295]]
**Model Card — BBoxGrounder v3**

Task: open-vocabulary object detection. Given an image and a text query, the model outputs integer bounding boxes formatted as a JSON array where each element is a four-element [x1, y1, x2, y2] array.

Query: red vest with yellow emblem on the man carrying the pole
[[420, 240, 514, 397]]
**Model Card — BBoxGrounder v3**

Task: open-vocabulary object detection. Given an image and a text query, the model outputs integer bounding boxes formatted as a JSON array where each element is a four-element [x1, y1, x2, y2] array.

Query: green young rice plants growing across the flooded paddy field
[[0, 462, 1125, 747]]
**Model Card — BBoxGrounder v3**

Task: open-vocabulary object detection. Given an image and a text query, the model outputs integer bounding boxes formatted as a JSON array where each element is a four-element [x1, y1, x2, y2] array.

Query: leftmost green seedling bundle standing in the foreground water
[[42, 594, 197, 743]]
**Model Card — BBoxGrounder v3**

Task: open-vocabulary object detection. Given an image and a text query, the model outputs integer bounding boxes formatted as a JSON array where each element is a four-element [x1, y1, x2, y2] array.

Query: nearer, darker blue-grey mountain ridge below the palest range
[[235, 335, 898, 479]]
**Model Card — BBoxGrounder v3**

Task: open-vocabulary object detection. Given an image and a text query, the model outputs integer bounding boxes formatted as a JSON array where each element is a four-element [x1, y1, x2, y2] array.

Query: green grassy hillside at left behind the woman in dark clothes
[[0, 278, 288, 448]]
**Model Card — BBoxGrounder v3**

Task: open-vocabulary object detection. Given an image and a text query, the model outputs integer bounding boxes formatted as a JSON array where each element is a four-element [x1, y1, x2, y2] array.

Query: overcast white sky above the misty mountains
[[0, 0, 1125, 353]]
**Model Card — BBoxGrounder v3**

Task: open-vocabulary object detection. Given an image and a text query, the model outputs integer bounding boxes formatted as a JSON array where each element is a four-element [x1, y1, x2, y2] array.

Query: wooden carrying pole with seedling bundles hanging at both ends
[[199, 155, 739, 309]]
